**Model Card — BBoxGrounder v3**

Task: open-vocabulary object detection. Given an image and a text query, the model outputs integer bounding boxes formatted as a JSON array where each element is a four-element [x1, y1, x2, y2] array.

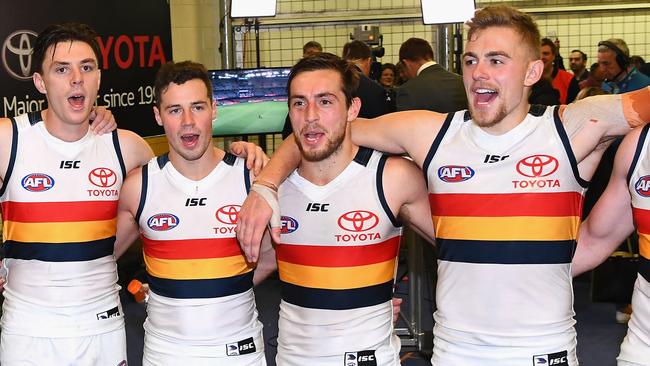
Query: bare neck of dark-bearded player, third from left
[[298, 137, 359, 186]]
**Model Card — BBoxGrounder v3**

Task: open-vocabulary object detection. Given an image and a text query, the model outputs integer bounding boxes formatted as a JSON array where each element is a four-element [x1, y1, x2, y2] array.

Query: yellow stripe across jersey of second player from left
[[144, 255, 252, 280]]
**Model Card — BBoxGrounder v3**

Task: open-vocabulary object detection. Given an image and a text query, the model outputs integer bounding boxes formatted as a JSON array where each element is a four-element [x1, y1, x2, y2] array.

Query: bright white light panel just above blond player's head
[[418, 0, 476, 24]]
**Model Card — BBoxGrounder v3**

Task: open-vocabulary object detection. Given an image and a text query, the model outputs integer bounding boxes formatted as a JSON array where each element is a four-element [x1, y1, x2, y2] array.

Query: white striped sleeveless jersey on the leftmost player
[[1, 112, 125, 337]]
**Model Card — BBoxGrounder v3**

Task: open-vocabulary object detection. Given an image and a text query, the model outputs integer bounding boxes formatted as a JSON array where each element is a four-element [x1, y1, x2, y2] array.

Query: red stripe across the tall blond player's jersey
[[429, 192, 583, 217]]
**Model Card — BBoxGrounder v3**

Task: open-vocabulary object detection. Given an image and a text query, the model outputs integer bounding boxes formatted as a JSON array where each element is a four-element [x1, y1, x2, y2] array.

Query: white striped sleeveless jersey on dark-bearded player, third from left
[[276, 147, 401, 366]]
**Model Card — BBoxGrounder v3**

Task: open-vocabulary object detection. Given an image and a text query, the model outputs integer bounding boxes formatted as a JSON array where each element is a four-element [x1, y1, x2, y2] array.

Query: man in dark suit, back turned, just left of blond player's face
[[396, 38, 467, 113]]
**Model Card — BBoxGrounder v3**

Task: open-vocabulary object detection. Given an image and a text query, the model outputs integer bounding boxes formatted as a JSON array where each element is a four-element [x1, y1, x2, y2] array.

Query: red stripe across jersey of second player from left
[[142, 235, 242, 259]]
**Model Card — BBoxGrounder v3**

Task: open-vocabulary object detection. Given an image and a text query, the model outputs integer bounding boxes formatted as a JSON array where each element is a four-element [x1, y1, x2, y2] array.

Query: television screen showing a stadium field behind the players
[[209, 67, 291, 136]]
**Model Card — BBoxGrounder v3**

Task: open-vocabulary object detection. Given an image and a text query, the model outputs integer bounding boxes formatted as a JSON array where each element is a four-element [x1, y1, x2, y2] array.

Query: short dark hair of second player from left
[[154, 61, 212, 108]]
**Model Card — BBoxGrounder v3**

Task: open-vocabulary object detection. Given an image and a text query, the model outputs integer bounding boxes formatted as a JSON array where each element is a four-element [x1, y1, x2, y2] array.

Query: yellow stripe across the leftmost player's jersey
[[2, 219, 117, 244]]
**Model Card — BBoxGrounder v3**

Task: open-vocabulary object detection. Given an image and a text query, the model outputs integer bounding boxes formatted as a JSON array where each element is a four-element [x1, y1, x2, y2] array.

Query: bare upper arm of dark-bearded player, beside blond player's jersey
[[383, 156, 435, 244]]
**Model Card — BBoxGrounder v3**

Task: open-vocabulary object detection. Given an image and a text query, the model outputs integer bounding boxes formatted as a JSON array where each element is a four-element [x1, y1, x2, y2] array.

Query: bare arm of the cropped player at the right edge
[[572, 127, 642, 276]]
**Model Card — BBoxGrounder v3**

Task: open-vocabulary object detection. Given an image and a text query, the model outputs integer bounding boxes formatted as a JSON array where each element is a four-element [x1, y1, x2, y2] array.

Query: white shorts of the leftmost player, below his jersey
[[0, 327, 126, 366]]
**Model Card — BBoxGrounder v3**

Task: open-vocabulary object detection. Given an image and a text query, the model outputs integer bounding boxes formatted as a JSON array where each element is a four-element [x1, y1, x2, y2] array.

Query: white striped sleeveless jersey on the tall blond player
[[424, 106, 587, 365]]
